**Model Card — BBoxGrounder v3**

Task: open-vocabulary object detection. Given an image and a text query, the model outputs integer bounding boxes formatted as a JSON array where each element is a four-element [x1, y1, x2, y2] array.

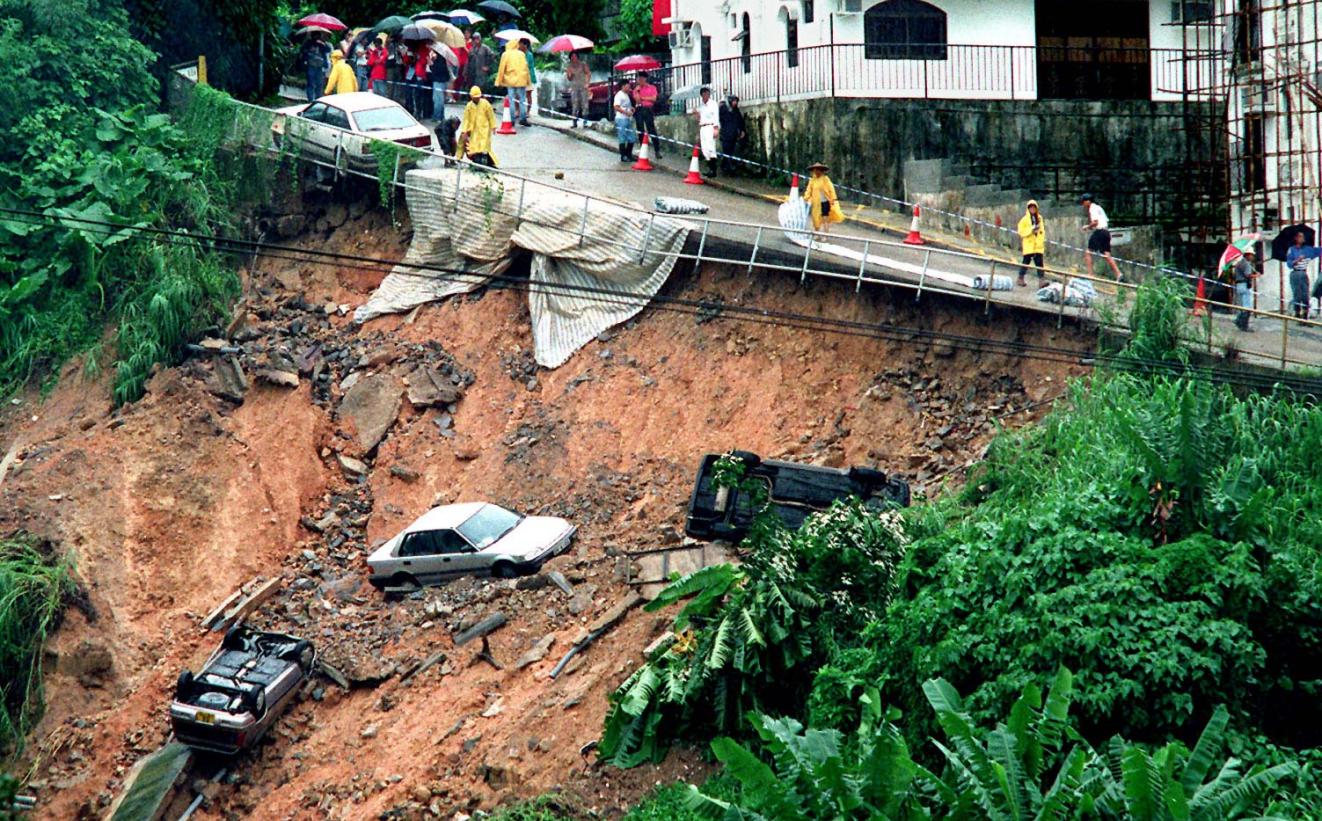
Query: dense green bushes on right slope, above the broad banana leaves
[[869, 375, 1322, 743]]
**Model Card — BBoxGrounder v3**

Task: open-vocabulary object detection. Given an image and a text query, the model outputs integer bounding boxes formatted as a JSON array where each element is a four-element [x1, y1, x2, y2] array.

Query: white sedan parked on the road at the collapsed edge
[[271, 91, 440, 172]]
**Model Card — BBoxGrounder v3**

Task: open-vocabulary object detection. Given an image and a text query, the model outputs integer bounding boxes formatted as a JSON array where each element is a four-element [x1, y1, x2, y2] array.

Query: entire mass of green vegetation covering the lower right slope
[[602, 284, 1322, 818]]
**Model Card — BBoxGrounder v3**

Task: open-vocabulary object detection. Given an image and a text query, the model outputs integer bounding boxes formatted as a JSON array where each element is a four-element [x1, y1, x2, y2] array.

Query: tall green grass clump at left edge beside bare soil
[[0, 534, 74, 754]]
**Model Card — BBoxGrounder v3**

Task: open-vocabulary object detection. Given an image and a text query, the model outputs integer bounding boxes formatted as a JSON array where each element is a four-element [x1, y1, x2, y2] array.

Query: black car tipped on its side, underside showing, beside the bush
[[683, 451, 910, 542]]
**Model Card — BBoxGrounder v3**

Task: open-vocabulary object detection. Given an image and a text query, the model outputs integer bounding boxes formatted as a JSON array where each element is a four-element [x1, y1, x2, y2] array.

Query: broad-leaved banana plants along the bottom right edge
[[687, 669, 1297, 821]]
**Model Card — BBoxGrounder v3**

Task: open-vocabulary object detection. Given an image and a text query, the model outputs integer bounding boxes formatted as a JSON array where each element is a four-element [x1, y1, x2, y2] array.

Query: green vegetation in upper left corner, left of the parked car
[[0, 0, 238, 402]]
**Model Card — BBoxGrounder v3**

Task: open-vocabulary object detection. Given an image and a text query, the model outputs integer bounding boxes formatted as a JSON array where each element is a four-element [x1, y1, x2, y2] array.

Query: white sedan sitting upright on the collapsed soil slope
[[368, 502, 578, 588]]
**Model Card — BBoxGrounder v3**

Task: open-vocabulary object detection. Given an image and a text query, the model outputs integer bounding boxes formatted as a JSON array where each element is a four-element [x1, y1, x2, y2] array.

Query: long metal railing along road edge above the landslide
[[178, 72, 1322, 370]]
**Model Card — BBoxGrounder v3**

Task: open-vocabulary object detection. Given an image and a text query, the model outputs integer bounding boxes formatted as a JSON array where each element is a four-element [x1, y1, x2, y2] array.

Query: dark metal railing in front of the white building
[[637, 42, 1224, 111]]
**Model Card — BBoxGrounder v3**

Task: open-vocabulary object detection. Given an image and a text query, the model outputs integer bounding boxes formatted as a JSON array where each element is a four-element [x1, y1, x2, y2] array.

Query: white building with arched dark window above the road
[[657, 0, 1216, 102]]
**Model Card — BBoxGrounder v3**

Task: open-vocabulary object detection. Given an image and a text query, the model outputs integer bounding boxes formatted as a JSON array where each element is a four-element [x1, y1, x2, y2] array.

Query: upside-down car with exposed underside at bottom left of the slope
[[169, 625, 316, 755]]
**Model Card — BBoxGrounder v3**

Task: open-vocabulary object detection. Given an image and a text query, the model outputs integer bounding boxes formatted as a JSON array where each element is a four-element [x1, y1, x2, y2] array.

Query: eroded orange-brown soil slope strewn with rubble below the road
[[0, 210, 1087, 818]]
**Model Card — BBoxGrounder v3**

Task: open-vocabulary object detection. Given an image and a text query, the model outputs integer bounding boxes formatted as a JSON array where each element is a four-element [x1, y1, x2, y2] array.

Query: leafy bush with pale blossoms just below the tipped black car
[[600, 467, 906, 767]]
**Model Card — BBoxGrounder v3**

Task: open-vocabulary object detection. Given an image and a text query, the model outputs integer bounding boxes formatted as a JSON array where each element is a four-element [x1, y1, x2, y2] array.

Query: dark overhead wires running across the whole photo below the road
[[0, 206, 1322, 394]]
